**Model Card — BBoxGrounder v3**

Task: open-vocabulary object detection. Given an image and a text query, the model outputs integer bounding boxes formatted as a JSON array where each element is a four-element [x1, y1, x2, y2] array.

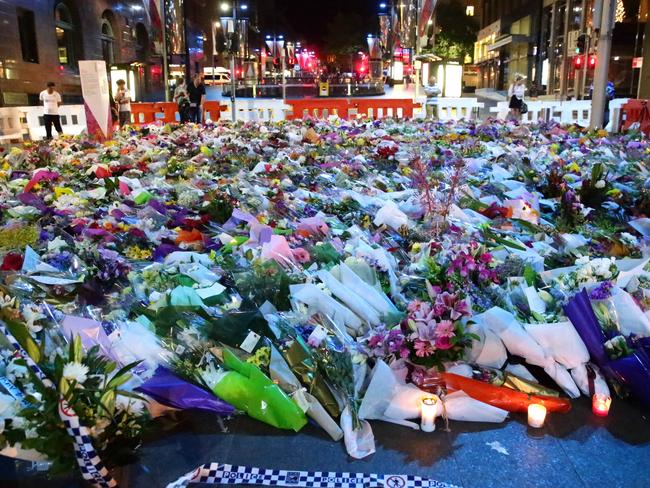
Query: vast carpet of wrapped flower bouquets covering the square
[[0, 119, 650, 480]]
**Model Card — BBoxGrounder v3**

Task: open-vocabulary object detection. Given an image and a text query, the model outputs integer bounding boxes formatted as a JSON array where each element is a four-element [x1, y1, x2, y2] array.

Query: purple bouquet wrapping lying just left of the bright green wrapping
[[136, 366, 235, 416]]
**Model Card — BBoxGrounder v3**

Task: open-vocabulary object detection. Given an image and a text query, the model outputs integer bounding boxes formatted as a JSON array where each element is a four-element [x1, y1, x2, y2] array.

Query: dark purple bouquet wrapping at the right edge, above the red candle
[[564, 289, 650, 406]]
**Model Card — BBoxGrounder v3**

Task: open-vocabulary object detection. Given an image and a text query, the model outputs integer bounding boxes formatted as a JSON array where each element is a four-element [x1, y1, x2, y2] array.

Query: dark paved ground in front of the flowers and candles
[[5, 398, 650, 488]]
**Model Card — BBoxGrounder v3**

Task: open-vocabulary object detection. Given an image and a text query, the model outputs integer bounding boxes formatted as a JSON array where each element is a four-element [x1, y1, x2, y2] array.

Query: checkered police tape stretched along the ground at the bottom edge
[[167, 463, 457, 488]]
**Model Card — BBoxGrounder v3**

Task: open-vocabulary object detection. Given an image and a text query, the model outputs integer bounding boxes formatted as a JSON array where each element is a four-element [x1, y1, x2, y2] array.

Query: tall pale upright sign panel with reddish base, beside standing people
[[79, 61, 113, 140]]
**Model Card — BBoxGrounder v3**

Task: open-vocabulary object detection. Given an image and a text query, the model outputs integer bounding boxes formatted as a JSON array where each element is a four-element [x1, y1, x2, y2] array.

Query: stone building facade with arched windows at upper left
[[0, 0, 164, 106]]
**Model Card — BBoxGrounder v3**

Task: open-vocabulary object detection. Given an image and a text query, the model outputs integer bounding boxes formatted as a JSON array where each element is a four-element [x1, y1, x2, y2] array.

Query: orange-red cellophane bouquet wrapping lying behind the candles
[[442, 373, 571, 413]]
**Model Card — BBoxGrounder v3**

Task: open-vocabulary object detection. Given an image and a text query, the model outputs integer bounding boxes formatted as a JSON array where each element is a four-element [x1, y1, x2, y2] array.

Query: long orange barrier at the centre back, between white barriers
[[284, 98, 422, 120]]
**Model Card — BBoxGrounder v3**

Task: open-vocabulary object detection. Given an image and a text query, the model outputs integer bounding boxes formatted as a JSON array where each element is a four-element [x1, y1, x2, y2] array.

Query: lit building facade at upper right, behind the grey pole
[[475, 0, 648, 98]]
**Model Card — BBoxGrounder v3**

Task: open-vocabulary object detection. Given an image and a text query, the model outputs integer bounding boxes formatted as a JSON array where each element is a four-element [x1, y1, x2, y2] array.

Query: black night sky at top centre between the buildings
[[253, 0, 379, 45]]
